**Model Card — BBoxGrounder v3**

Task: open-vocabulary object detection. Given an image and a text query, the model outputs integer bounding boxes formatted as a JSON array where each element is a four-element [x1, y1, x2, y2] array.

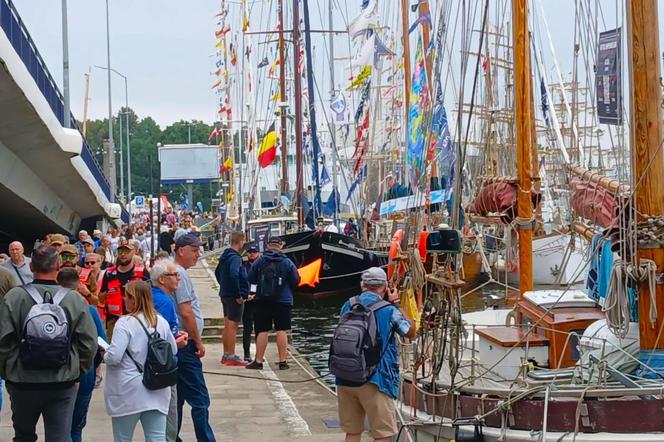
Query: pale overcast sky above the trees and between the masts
[[14, 0, 662, 127]]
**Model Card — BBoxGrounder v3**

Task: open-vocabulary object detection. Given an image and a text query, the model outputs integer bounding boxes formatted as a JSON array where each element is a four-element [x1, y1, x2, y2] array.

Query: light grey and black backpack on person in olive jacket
[[19, 284, 70, 370]]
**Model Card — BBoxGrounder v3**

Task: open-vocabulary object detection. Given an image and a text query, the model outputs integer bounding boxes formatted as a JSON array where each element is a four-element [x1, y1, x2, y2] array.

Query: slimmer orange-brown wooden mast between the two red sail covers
[[512, 0, 533, 299]]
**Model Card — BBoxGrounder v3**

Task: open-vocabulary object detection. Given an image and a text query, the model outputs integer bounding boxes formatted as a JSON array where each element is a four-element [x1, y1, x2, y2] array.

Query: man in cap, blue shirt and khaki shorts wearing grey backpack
[[330, 267, 416, 442]]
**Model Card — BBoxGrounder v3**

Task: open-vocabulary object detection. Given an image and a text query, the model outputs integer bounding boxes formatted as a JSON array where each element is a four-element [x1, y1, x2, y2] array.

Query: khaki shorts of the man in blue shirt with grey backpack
[[337, 383, 399, 439]]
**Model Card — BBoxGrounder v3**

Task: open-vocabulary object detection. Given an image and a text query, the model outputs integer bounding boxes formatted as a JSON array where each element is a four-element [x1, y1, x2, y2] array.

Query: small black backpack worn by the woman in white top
[[127, 318, 178, 390]]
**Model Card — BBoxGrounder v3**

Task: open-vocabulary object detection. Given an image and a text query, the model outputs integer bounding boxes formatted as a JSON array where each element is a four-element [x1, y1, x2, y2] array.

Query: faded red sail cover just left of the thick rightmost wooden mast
[[572, 178, 619, 227]]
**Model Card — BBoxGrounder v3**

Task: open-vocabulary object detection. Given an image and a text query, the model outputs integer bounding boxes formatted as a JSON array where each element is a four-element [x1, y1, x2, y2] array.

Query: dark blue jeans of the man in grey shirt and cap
[[178, 341, 216, 442]]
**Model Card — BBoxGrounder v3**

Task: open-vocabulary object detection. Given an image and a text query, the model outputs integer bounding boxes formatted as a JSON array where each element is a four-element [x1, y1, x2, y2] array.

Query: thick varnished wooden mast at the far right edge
[[625, 0, 664, 352]]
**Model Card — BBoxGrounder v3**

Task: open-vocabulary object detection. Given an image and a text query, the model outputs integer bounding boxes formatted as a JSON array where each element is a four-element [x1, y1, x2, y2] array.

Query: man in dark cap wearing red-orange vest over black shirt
[[99, 243, 150, 339]]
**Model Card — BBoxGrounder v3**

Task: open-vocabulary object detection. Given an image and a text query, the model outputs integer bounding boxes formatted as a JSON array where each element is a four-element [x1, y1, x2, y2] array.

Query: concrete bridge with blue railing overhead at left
[[0, 0, 128, 244]]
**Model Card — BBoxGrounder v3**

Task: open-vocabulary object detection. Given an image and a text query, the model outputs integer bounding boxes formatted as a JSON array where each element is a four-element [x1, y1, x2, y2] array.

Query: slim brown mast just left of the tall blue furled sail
[[293, 0, 304, 225]]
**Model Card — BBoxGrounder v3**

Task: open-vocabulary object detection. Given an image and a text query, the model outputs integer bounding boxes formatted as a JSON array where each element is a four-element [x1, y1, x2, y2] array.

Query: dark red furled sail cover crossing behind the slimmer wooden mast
[[468, 182, 542, 224]]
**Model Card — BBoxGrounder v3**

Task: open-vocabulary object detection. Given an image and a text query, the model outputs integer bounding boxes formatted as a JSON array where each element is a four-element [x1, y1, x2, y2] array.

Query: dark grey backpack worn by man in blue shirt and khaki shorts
[[329, 297, 392, 384]]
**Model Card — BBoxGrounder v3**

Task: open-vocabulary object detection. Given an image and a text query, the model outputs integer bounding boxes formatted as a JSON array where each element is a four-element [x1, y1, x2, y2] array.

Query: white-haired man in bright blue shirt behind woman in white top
[[150, 258, 188, 442]]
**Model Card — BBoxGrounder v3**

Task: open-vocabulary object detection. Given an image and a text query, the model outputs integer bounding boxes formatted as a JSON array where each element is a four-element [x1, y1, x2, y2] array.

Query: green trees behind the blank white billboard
[[81, 112, 219, 210]]
